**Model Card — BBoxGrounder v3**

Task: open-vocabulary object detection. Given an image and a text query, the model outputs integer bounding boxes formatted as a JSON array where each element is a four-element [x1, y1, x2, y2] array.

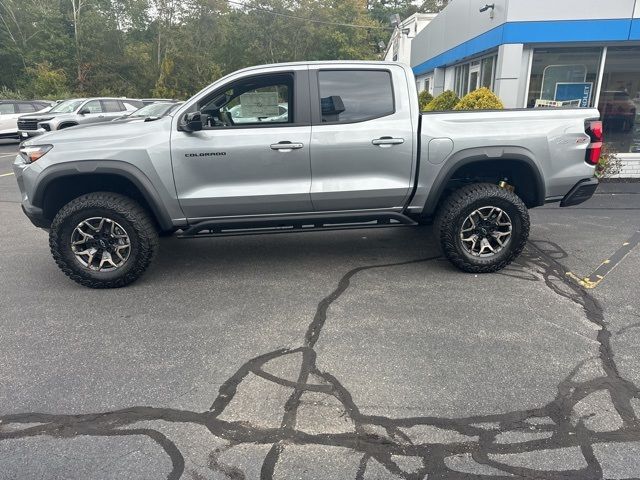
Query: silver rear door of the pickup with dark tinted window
[[309, 66, 418, 211]]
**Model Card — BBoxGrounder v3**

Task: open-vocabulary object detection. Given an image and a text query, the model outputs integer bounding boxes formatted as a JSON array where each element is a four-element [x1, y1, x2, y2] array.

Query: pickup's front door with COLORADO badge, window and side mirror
[[171, 66, 313, 219]]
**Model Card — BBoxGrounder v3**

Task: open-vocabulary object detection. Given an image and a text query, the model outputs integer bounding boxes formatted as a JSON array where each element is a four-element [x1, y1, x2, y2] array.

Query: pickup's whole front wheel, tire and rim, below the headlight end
[[49, 192, 158, 288]]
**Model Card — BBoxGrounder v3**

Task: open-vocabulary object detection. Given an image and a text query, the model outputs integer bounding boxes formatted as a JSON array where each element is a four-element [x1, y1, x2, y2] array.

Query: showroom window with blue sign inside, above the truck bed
[[527, 47, 602, 108]]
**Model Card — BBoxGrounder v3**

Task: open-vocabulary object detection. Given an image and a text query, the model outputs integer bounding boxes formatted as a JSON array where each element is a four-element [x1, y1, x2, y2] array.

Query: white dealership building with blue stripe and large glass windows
[[411, 0, 640, 163]]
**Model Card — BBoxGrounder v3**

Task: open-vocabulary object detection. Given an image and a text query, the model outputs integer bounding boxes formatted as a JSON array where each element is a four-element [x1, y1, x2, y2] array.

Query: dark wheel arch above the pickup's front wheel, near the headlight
[[32, 161, 173, 231]]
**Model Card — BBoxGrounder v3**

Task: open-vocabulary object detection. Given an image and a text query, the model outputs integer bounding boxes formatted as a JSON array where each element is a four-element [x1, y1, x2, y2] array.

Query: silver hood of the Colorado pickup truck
[[23, 116, 171, 147]]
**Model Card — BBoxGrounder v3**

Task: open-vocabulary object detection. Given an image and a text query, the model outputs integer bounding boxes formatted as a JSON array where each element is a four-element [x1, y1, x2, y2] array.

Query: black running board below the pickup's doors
[[177, 212, 417, 238]]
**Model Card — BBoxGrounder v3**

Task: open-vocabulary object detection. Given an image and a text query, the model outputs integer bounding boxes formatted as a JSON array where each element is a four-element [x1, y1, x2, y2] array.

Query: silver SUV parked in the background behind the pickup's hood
[[18, 98, 143, 139]]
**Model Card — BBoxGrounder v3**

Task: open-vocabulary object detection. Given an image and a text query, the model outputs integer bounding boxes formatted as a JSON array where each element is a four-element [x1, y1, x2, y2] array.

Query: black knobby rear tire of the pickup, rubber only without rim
[[435, 183, 530, 273]]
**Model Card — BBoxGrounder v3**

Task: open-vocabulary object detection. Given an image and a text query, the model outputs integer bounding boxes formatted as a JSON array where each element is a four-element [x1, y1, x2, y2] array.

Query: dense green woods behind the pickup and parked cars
[[0, 0, 398, 97]]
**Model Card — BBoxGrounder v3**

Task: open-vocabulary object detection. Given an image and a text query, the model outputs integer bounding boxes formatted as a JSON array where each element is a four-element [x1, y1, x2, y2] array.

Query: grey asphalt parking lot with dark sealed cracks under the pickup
[[0, 138, 640, 480]]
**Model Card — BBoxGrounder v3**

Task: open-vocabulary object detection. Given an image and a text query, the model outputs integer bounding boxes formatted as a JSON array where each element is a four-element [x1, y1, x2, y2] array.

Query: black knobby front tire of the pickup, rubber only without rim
[[49, 192, 158, 288]]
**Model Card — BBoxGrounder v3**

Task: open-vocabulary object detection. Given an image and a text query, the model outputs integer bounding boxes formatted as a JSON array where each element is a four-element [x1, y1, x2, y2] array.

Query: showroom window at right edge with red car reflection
[[598, 46, 640, 153]]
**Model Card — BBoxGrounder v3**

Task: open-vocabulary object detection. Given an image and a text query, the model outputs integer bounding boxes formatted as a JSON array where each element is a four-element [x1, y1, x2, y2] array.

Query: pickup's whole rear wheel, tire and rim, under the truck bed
[[436, 183, 529, 273]]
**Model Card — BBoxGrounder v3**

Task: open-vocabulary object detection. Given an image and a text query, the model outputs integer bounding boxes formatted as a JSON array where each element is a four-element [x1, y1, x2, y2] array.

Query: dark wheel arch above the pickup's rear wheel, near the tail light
[[422, 149, 545, 217]]
